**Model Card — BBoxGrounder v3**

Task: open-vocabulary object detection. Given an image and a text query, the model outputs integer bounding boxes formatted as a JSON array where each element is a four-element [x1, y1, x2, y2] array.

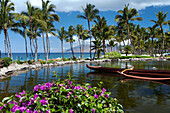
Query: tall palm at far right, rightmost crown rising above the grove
[[150, 11, 169, 56]]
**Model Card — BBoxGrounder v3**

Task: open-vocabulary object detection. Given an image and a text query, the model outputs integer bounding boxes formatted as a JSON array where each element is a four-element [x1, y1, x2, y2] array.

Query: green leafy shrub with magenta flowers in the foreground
[[0, 74, 123, 113]]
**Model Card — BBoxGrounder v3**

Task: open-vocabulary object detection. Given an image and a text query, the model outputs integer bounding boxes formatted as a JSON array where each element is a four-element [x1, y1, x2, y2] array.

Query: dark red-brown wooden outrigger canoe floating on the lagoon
[[86, 64, 170, 80]]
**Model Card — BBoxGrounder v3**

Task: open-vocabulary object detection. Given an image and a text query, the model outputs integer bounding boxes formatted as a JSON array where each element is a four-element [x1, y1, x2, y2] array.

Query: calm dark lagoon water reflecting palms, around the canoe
[[0, 61, 170, 113]]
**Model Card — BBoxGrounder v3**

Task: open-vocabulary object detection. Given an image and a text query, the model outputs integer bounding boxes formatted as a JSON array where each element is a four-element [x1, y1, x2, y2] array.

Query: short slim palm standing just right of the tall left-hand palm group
[[57, 27, 67, 58]]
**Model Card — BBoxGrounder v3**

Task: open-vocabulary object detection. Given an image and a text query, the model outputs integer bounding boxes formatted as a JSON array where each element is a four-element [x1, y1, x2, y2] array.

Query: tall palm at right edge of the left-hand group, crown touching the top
[[42, 0, 60, 60]]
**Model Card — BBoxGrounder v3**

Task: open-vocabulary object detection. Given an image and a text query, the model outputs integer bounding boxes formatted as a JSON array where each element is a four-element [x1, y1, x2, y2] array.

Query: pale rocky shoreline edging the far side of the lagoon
[[0, 58, 169, 80]]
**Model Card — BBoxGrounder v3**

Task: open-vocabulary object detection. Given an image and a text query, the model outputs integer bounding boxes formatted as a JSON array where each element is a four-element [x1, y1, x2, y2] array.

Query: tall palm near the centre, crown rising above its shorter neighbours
[[77, 4, 99, 59]]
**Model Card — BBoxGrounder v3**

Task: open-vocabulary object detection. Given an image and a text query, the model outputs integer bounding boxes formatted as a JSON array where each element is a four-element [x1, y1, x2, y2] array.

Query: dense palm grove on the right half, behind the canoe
[[77, 4, 170, 58]]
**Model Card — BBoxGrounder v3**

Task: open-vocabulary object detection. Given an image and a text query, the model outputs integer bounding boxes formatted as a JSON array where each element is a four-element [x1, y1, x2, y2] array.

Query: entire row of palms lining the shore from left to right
[[0, 0, 170, 61]]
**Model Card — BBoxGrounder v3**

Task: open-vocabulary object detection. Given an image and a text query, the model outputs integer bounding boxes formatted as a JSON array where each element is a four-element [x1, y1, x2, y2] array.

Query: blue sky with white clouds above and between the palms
[[0, 0, 170, 53]]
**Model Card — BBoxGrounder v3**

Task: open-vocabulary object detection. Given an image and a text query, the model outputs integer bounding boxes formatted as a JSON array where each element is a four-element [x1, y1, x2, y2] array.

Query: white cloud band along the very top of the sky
[[12, 0, 170, 12]]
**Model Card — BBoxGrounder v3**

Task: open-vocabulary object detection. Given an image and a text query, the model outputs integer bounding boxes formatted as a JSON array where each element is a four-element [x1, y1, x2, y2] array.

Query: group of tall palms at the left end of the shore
[[0, 0, 60, 61]]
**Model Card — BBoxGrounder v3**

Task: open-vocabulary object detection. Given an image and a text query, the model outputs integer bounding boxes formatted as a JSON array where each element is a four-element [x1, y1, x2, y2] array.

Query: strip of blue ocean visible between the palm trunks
[[1, 53, 93, 61]]
